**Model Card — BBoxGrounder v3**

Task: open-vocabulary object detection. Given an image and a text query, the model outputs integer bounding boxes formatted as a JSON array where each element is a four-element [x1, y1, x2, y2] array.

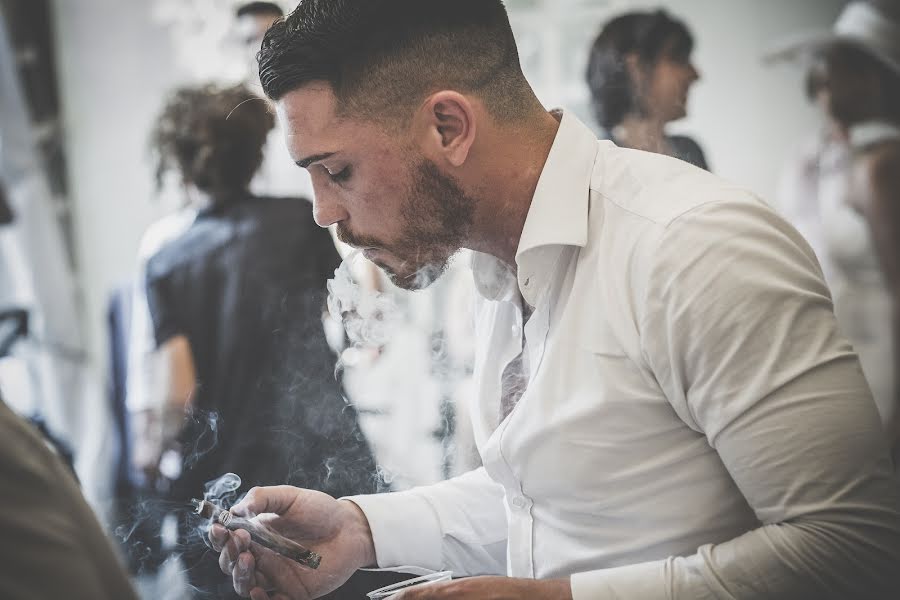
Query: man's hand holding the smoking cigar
[[209, 486, 375, 600]]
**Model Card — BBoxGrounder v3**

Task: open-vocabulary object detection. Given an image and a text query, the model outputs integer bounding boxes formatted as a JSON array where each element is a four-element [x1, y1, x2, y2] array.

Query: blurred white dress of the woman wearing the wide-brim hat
[[819, 122, 900, 424]]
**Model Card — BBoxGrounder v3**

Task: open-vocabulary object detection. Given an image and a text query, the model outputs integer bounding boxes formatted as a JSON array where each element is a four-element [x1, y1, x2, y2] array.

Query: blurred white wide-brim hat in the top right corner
[[764, 1, 900, 74]]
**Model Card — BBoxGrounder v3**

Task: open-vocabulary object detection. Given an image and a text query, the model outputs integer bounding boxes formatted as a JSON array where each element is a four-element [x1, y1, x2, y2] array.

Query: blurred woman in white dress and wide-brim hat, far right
[[772, 2, 900, 464]]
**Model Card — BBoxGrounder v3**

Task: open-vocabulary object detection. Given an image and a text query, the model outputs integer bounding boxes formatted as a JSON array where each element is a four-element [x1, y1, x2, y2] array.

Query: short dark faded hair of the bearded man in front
[[258, 0, 534, 121]]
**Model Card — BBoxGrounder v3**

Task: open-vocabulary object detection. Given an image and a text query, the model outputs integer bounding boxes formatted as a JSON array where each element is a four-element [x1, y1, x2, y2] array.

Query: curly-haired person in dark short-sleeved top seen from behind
[[145, 86, 379, 597]]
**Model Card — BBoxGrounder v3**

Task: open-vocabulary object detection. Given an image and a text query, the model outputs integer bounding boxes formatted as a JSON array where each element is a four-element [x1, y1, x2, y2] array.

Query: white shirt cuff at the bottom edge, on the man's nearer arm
[[570, 560, 669, 600]]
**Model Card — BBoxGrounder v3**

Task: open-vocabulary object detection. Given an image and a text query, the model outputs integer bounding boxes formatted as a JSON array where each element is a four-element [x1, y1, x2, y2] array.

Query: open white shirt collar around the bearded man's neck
[[472, 112, 598, 306]]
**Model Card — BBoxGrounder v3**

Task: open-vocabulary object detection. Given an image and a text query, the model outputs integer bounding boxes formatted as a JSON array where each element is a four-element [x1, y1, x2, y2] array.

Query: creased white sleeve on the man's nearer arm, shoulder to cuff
[[572, 199, 900, 600]]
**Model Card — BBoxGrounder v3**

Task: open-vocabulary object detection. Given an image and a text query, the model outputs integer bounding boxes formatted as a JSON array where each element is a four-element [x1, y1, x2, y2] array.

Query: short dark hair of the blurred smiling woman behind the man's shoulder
[[587, 10, 694, 130]]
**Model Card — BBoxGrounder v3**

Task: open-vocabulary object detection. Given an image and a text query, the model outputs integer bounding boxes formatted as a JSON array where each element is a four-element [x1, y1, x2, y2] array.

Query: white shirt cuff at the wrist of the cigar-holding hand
[[342, 490, 444, 571]]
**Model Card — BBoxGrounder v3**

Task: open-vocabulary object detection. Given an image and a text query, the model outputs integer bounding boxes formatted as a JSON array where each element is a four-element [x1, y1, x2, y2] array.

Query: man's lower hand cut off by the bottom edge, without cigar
[[391, 577, 572, 600]]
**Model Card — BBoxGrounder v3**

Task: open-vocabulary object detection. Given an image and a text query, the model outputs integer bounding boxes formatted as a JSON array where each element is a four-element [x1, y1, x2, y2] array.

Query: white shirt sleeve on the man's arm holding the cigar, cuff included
[[347, 468, 507, 576]]
